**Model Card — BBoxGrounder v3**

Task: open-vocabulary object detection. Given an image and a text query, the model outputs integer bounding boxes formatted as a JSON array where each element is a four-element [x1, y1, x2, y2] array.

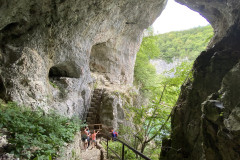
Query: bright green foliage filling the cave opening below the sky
[[131, 26, 210, 159]]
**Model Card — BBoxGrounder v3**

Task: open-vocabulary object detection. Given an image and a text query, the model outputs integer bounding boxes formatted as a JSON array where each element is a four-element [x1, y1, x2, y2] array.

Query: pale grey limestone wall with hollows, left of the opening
[[0, 0, 166, 117]]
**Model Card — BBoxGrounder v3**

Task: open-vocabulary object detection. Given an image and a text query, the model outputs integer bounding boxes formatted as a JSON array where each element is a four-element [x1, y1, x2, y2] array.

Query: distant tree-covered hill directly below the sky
[[142, 25, 213, 62]]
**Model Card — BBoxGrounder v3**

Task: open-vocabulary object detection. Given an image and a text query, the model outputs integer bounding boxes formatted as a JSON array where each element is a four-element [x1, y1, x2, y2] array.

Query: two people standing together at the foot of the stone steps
[[82, 127, 99, 150]]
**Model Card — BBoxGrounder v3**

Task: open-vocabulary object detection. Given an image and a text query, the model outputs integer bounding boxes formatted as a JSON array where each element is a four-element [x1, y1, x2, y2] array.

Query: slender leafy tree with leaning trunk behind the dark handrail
[[130, 62, 192, 156]]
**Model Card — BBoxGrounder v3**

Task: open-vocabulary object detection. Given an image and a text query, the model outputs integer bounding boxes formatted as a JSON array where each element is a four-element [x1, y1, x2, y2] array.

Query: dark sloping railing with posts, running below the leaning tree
[[101, 135, 151, 160]]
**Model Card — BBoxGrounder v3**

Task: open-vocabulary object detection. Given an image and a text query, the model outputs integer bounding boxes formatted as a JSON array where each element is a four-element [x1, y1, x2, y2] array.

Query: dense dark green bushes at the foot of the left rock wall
[[0, 102, 82, 160]]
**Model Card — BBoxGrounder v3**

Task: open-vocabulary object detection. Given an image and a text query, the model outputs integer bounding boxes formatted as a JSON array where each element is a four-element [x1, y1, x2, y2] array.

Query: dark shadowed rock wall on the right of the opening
[[161, 0, 240, 160]]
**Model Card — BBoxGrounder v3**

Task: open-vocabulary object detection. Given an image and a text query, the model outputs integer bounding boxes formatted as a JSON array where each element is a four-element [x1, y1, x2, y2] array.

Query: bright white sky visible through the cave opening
[[153, 0, 209, 34]]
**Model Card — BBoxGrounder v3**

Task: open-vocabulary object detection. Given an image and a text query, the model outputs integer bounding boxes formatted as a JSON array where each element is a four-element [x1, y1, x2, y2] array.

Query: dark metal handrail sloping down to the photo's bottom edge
[[101, 134, 151, 160]]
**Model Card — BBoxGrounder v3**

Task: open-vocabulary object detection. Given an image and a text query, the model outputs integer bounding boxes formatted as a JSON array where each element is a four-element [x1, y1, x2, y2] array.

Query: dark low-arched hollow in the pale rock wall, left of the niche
[[48, 62, 82, 78]]
